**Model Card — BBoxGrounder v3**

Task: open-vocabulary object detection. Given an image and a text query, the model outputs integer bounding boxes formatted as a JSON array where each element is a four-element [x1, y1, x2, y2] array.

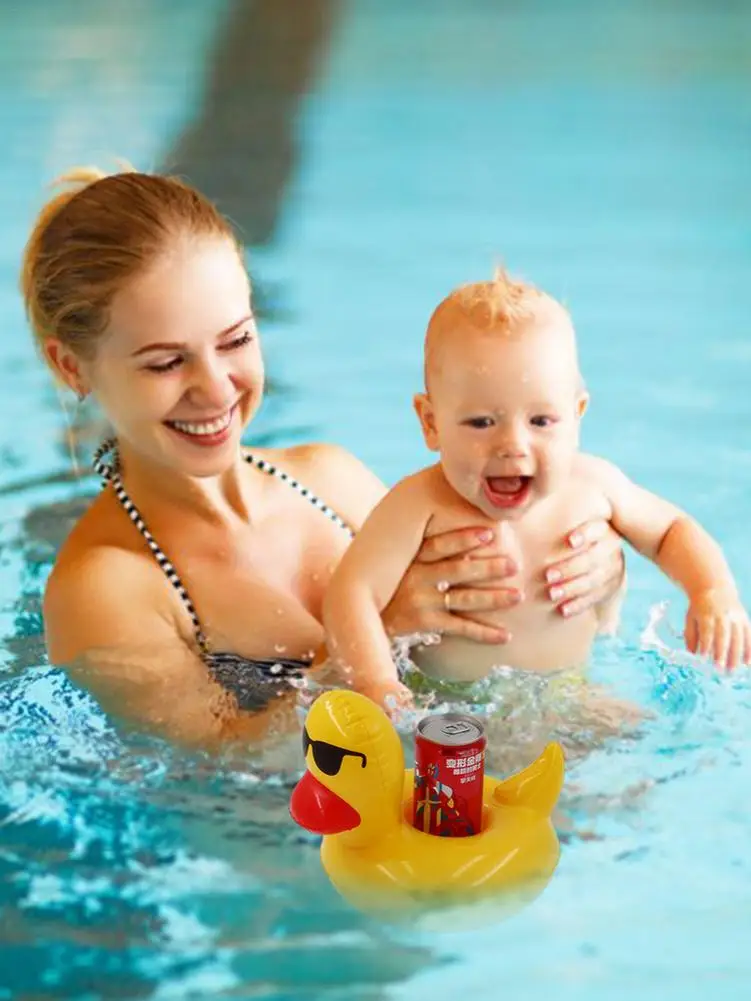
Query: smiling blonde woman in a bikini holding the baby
[[22, 170, 623, 745]]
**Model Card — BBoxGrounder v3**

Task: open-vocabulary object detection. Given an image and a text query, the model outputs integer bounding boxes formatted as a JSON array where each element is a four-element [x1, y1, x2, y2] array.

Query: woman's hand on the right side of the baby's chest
[[546, 519, 626, 617]]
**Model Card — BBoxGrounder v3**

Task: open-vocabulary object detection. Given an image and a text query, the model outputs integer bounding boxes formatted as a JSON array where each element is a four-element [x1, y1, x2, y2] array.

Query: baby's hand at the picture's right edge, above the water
[[684, 590, 751, 671]]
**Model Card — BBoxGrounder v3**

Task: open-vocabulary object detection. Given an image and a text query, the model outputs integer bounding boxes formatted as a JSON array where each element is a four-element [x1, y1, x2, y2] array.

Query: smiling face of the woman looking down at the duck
[[81, 237, 263, 476]]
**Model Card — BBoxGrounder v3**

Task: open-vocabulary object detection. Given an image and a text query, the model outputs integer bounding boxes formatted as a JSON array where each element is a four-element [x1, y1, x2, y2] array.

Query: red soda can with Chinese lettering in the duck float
[[413, 713, 487, 838]]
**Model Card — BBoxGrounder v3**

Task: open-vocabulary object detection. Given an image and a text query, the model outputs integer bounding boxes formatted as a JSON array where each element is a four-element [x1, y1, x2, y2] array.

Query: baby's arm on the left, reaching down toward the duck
[[323, 472, 431, 702]]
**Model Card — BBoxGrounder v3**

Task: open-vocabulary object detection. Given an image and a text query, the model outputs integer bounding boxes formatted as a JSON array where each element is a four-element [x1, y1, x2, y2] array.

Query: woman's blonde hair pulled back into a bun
[[21, 167, 239, 368]]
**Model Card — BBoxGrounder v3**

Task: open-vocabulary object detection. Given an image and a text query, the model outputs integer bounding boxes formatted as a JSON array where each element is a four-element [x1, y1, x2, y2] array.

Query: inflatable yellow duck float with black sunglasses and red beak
[[289, 690, 564, 917]]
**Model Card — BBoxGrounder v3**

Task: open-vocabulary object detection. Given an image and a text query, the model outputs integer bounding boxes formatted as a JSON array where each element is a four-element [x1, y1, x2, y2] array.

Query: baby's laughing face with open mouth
[[418, 319, 587, 521]]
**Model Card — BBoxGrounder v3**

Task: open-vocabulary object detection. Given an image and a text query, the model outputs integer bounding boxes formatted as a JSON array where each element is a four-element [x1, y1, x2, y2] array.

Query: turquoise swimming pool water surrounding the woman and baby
[[0, 0, 751, 1001]]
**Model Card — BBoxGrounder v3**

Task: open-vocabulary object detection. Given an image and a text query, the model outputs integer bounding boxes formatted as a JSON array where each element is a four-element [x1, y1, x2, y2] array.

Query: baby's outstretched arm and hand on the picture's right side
[[587, 456, 751, 668]]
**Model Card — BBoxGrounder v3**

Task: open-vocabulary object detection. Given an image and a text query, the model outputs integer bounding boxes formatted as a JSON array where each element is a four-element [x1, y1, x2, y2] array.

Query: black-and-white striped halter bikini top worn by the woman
[[92, 438, 354, 710]]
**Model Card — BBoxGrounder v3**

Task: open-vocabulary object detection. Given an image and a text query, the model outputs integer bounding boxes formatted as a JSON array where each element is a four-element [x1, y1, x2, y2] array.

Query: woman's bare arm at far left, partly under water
[[44, 549, 293, 749]]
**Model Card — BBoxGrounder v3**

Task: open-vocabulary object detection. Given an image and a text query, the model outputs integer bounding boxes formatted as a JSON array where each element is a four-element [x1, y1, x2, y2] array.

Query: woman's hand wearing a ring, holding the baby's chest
[[383, 528, 522, 643]]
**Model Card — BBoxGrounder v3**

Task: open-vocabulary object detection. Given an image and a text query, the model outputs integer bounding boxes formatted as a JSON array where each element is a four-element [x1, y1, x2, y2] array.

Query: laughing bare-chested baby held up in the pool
[[323, 273, 751, 704]]
